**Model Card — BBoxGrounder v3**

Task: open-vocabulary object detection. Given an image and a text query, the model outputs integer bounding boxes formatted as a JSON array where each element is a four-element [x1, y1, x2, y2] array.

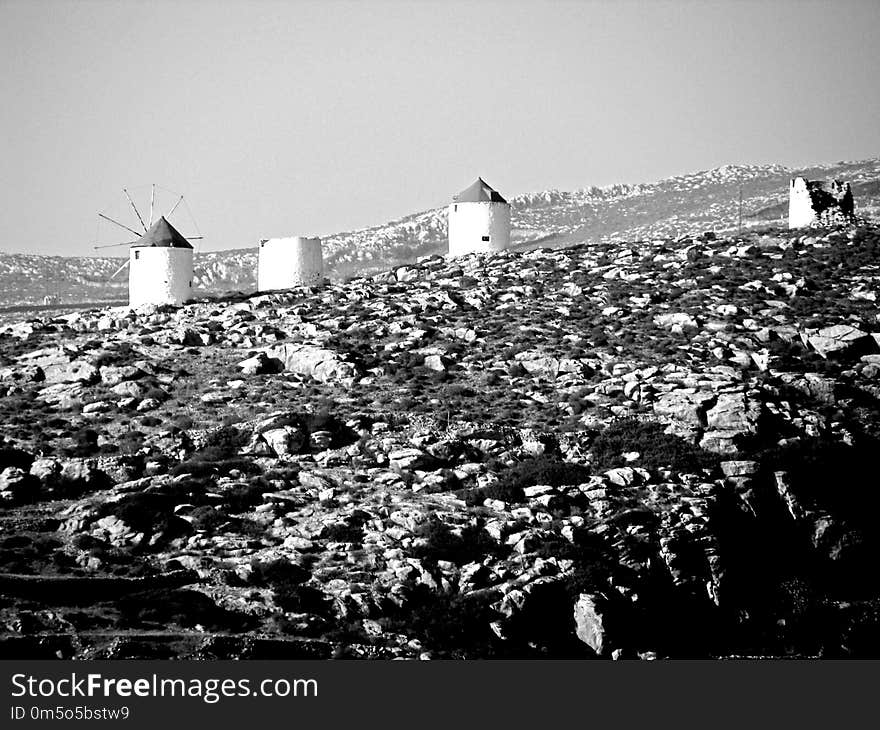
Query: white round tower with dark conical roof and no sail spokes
[[449, 178, 510, 256]]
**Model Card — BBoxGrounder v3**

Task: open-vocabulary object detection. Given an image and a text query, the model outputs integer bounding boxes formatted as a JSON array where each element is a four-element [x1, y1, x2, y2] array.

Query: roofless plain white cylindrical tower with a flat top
[[257, 236, 324, 291]]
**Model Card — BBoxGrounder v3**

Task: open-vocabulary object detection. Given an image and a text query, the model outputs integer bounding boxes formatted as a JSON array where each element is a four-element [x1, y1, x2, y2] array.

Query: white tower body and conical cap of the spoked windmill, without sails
[[128, 217, 193, 307]]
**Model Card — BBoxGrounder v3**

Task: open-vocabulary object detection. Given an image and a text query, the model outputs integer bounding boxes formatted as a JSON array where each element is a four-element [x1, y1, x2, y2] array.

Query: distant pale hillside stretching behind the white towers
[[0, 158, 880, 320]]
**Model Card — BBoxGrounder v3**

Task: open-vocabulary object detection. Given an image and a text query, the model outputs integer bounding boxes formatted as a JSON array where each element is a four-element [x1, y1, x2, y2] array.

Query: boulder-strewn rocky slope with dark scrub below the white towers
[[0, 220, 880, 658]]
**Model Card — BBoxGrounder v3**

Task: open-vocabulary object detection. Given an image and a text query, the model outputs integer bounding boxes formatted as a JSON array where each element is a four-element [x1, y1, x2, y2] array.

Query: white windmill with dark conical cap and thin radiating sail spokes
[[95, 185, 203, 307]]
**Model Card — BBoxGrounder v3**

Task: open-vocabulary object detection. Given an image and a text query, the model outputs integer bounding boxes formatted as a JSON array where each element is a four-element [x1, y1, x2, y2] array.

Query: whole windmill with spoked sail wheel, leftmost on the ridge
[[94, 184, 203, 306]]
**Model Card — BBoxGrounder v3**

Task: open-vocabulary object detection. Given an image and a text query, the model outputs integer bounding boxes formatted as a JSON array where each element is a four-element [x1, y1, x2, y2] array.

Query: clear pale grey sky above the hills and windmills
[[0, 0, 880, 255]]
